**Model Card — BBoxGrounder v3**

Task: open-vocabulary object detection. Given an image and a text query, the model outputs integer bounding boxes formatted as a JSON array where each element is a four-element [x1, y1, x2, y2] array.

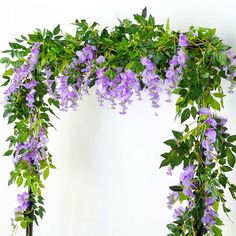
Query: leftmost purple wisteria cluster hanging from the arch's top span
[[53, 45, 108, 111]]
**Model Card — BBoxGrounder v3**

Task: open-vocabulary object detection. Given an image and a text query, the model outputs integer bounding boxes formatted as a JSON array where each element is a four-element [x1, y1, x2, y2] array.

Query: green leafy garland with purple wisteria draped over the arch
[[0, 9, 236, 236]]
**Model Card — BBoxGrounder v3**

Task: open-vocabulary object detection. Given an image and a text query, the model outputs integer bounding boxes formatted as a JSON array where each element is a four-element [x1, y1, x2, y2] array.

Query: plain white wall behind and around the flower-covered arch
[[0, 0, 236, 236]]
